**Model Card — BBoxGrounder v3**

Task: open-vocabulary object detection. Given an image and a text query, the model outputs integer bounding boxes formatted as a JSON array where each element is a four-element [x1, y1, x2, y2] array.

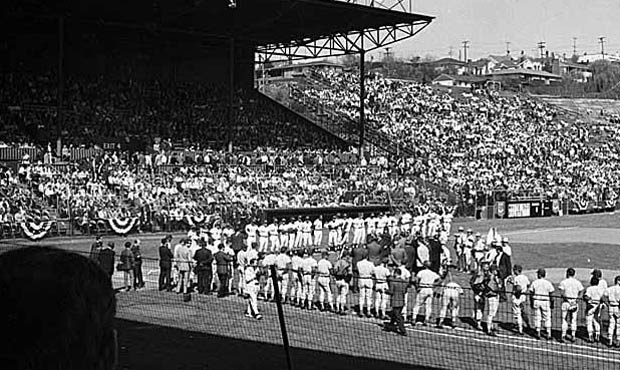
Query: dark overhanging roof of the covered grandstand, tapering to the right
[[4, 0, 433, 46]]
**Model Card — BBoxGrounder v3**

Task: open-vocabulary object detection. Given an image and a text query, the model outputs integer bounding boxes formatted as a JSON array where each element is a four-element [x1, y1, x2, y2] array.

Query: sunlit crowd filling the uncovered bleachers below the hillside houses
[[295, 70, 620, 200]]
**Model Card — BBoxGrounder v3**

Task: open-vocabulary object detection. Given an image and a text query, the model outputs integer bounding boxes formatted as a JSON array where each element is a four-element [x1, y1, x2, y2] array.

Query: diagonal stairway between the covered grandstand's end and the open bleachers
[[261, 74, 414, 156]]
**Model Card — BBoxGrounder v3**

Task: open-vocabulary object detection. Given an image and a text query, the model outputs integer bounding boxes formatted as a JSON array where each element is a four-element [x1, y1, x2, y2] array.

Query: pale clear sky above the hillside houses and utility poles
[[371, 0, 620, 60]]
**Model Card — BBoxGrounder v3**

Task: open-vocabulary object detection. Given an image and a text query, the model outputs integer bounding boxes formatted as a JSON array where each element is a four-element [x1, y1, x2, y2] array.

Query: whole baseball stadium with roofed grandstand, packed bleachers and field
[[0, 0, 620, 370]]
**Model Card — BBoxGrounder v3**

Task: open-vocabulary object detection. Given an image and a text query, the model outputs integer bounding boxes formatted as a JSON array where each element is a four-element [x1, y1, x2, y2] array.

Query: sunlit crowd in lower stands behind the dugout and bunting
[[0, 141, 446, 232]]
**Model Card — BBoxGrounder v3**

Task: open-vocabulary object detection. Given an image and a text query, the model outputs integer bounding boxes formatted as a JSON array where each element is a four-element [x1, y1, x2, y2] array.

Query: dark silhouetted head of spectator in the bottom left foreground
[[0, 247, 117, 370]]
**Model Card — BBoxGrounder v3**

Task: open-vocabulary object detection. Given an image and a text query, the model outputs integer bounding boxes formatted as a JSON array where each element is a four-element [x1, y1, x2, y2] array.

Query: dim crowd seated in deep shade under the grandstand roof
[[0, 73, 337, 149]]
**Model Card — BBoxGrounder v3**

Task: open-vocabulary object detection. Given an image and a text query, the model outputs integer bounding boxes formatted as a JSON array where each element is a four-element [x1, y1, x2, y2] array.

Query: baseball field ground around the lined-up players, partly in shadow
[[5, 214, 620, 369]]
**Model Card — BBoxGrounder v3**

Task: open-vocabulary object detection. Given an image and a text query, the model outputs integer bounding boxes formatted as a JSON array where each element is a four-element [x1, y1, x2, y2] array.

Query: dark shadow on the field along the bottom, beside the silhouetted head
[[116, 319, 444, 370]]
